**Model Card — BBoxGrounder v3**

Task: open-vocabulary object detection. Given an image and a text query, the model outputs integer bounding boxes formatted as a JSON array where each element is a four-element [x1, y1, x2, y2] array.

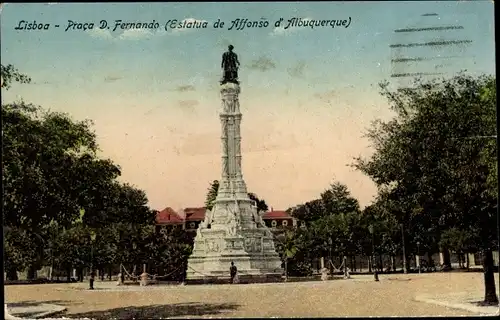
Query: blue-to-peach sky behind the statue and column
[[1, 1, 495, 210]]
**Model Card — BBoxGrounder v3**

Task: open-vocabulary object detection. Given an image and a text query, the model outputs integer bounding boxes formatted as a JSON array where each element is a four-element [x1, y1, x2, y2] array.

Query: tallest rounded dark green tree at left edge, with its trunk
[[2, 102, 127, 277]]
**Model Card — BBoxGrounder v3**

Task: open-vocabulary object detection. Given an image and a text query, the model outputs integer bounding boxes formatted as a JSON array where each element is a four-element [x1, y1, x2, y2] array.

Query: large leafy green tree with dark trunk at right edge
[[354, 74, 498, 304]]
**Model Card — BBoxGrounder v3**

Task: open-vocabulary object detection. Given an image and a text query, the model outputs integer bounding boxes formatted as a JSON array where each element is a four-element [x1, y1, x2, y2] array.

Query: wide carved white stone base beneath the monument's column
[[187, 202, 283, 280]]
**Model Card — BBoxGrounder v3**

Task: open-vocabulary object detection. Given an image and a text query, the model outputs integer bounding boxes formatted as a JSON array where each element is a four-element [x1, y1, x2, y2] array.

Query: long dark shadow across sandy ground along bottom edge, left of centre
[[65, 303, 238, 319]]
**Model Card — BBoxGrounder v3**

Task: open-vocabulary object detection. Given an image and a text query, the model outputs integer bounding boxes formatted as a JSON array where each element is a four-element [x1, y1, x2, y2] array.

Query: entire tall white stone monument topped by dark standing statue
[[186, 46, 283, 280]]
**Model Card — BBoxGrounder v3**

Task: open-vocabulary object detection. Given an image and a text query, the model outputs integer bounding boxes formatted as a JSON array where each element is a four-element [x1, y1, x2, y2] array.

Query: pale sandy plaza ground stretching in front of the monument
[[5, 272, 498, 319]]
